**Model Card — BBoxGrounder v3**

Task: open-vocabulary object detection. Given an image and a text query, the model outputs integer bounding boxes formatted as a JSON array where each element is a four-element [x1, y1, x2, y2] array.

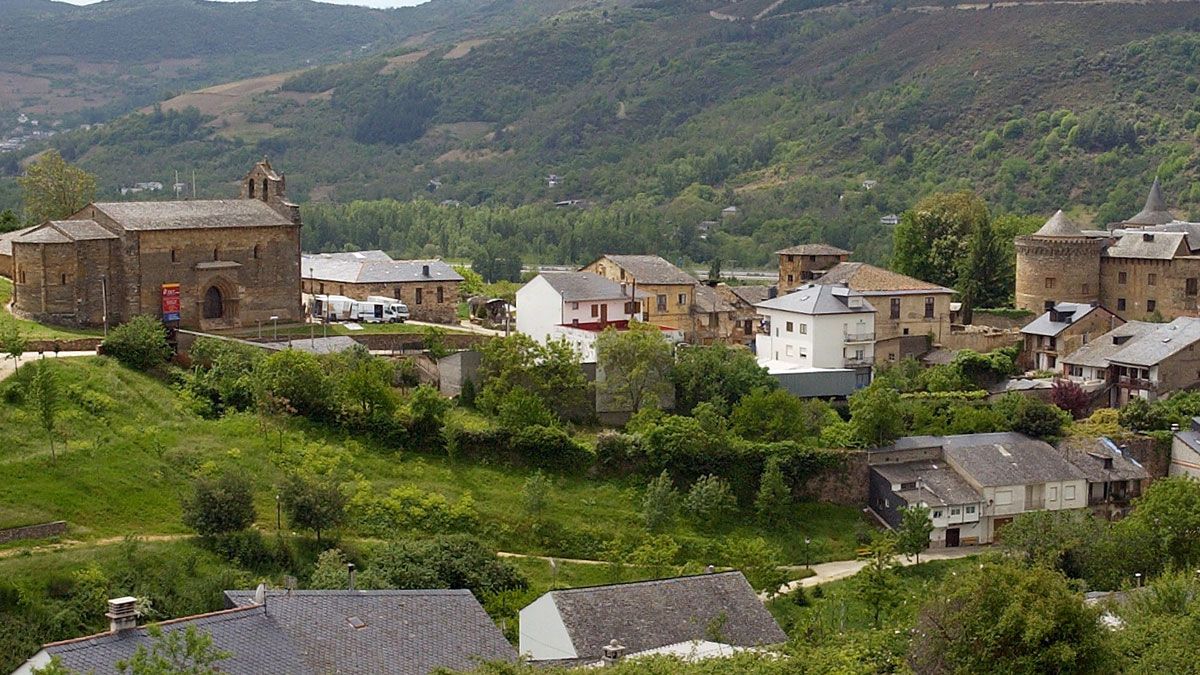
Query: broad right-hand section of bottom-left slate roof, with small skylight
[[226, 590, 516, 675]]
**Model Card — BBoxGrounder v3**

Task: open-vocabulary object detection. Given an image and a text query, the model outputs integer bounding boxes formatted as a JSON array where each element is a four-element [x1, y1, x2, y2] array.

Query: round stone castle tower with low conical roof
[[1015, 210, 1104, 313]]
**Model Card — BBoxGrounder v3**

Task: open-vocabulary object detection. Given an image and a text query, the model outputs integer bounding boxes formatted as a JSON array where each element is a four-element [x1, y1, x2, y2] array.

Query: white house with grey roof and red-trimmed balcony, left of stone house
[[516, 271, 683, 363]]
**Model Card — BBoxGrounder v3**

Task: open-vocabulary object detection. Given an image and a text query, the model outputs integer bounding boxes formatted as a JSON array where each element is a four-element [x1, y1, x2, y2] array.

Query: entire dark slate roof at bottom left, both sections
[[32, 591, 516, 675]]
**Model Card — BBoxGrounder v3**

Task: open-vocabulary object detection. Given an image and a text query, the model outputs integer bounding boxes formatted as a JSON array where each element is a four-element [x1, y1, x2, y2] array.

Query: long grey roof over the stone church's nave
[[85, 199, 295, 231]]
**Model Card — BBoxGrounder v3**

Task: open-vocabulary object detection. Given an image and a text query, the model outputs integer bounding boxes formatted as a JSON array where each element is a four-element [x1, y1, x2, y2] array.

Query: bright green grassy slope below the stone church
[[0, 357, 869, 565]]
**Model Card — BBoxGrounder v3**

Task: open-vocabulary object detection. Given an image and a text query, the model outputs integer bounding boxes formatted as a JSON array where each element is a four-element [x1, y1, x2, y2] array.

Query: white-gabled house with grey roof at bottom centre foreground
[[518, 572, 787, 667]]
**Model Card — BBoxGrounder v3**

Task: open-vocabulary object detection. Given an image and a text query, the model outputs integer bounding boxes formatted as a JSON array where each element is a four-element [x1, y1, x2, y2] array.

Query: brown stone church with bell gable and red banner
[[4, 159, 302, 330]]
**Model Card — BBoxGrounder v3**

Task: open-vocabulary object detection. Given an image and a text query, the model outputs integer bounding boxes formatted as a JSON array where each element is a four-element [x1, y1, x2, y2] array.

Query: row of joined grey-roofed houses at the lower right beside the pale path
[[868, 432, 1150, 548]]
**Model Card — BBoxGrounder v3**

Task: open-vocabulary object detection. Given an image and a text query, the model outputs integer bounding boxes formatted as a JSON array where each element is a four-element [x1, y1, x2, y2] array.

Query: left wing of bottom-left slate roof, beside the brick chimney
[[44, 608, 313, 675]]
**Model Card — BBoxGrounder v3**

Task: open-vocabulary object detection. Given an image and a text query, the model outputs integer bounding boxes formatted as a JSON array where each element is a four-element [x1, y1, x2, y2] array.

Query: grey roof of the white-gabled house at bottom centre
[[550, 572, 787, 659]]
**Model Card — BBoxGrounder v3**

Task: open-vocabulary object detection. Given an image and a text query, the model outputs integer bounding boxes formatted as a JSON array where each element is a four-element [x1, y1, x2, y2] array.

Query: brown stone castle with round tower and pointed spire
[[1015, 180, 1200, 321]]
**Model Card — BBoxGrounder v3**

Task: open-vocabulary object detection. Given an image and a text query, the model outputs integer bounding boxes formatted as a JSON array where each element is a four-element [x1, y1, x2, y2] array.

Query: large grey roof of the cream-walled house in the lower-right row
[[942, 431, 1086, 488]]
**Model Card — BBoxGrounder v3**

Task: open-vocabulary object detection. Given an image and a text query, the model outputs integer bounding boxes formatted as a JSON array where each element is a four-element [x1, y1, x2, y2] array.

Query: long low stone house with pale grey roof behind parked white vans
[[300, 251, 462, 323]]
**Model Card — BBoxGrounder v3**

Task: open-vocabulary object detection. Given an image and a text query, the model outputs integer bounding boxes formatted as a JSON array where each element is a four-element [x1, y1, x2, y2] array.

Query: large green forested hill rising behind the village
[[18, 0, 1200, 264]]
